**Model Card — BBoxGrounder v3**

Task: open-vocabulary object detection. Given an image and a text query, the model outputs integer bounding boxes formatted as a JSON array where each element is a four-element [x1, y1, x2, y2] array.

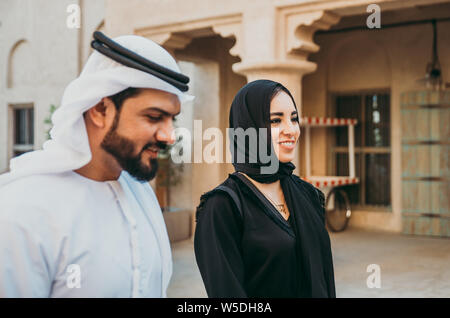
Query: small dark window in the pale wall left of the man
[[12, 105, 34, 157]]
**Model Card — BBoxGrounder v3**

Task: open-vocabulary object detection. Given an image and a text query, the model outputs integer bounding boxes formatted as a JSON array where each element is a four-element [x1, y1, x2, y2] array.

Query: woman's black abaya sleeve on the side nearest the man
[[194, 193, 247, 297]]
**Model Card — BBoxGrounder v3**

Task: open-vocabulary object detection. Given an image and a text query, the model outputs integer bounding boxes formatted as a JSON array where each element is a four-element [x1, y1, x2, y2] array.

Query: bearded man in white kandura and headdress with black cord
[[0, 32, 193, 297]]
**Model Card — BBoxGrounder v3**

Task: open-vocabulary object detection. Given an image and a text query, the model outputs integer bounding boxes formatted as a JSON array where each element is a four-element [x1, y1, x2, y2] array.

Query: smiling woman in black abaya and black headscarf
[[194, 80, 336, 298]]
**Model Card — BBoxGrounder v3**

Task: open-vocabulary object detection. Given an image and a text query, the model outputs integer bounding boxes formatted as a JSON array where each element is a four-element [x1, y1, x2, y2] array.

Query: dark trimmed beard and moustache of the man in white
[[101, 113, 166, 182]]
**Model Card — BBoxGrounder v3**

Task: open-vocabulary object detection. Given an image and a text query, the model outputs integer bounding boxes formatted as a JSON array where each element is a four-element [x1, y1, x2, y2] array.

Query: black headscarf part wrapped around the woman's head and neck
[[229, 80, 297, 183]]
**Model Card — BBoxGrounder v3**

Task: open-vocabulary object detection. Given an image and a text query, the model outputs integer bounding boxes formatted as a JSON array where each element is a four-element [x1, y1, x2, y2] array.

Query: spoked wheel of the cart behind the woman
[[325, 188, 352, 232]]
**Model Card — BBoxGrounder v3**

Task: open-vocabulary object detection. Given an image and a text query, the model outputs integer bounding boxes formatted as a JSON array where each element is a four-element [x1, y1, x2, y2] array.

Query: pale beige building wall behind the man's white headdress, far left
[[0, 0, 104, 173]]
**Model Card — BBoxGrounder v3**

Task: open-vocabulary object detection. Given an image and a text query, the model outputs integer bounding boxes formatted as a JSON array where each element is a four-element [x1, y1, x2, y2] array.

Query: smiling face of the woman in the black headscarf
[[270, 91, 300, 163]]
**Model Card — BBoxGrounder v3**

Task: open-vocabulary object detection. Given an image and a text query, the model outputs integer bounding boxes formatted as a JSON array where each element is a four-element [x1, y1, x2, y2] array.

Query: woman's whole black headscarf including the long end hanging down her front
[[230, 80, 336, 297]]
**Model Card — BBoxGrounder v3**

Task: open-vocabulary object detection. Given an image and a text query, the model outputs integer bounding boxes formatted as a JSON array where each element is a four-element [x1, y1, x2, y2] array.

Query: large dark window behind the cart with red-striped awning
[[331, 92, 391, 208]]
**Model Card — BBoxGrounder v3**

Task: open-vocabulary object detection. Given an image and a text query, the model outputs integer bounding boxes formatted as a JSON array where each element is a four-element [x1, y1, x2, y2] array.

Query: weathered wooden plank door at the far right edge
[[401, 90, 450, 237]]
